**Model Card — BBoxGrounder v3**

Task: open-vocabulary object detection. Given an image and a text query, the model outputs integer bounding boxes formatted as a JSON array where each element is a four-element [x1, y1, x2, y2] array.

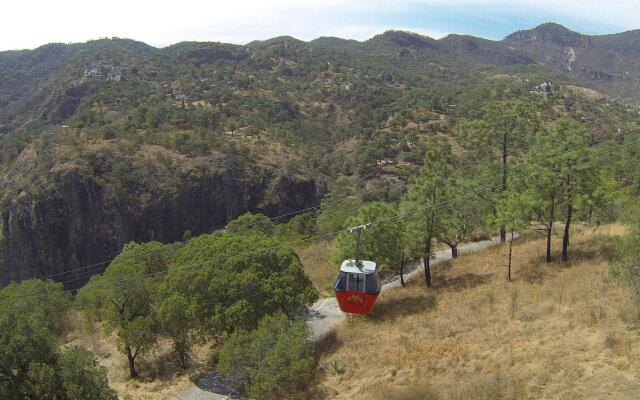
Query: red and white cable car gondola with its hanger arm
[[334, 225, 381, 315]]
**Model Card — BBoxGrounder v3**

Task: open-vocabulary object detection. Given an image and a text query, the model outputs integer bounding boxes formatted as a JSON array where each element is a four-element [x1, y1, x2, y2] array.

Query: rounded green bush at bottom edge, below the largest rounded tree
[[218, 312, 315, 399]]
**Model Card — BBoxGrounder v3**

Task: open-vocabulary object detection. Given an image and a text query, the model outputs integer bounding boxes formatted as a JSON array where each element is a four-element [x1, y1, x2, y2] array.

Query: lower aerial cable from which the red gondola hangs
[[2, 133, 640, 299]]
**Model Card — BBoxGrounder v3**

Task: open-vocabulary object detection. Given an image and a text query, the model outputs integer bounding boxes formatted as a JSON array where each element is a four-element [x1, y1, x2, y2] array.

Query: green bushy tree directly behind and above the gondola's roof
[[334, 202, 404, 268]]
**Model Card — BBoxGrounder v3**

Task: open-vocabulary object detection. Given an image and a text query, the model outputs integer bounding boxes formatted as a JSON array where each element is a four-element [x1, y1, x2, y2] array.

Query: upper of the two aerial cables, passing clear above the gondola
[[12, 126, 630, 289]]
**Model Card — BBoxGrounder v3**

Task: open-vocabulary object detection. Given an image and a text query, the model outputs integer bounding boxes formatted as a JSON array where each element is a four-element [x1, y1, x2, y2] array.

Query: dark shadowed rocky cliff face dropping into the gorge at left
[[0, 157, 318, 287]]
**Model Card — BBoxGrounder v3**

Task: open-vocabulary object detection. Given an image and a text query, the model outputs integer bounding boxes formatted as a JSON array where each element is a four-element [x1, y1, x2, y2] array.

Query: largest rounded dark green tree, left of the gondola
[[165, 231, 318, 336]]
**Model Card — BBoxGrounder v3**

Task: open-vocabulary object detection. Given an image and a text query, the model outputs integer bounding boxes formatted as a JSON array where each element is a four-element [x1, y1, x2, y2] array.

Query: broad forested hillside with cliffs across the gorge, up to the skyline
[[0, 21, 638, 284]]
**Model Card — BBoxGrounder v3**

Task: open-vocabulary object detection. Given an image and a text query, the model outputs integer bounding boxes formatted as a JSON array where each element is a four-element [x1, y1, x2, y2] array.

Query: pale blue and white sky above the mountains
[[0, 0, 640, 50]]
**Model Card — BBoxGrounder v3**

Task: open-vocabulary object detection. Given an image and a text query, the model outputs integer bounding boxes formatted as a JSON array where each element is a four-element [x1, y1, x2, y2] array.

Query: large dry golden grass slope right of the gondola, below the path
[[301, 225, 640, 399]]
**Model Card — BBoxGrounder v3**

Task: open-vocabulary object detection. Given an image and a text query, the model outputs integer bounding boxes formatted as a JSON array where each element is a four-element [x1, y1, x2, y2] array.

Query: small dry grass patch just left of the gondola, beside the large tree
[[297, 240, 339, 297]]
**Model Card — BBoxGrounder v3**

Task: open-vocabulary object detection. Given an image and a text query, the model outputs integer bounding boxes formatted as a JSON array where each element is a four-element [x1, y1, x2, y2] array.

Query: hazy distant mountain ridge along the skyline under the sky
[[0, 22, 640, 106]]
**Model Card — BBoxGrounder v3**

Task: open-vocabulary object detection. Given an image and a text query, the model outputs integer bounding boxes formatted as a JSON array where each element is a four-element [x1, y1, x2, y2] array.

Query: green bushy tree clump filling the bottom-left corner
[[0, 280, 117, 400]]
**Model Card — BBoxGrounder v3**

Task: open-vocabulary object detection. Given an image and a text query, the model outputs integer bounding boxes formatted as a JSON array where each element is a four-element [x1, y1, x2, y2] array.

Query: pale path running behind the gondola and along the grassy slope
[[180, 234, 517, 400]]
